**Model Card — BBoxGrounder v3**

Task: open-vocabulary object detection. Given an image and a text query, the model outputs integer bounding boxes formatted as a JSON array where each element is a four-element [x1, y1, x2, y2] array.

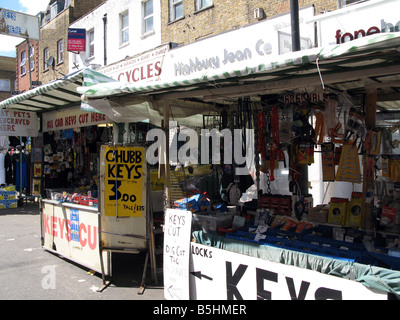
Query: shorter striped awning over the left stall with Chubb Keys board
[[0, 68, 115, 113]]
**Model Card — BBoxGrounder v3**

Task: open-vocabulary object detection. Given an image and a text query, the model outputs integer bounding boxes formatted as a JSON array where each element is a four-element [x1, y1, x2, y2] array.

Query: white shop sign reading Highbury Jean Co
[[166, 6, 315, 83]]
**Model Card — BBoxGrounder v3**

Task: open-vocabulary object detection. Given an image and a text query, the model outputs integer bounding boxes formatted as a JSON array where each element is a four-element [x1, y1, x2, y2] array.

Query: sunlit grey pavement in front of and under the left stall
[[0, 203, 164, 301]]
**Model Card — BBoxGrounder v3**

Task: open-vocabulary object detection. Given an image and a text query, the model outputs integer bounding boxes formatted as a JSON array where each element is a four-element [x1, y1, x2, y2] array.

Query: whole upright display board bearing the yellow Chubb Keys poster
[[99, 145, 148, 251]]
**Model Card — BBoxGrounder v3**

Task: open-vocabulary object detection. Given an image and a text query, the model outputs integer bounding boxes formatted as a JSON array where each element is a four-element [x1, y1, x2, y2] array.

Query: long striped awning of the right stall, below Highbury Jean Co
[[77, 33, 400, 109]]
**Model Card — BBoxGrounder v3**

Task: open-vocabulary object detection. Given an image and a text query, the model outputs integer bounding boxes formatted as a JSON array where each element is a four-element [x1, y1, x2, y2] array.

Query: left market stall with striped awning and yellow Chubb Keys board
[[1, 69, 162, 293]]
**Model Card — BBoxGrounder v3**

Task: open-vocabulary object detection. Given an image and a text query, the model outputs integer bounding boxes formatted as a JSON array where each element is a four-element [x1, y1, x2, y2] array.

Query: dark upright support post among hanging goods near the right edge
[[361, 87, 378, 230]]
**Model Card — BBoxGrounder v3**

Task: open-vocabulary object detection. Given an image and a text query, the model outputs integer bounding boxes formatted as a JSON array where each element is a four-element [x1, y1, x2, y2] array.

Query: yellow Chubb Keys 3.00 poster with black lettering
[[104, 147, 146, 217]]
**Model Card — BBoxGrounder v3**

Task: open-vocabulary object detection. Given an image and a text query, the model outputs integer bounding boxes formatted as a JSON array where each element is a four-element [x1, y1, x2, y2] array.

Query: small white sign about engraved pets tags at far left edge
[[0, 109, 39, 137]]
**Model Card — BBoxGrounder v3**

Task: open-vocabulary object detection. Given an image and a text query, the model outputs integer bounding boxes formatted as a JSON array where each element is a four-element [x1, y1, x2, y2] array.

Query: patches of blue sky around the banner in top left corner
[[0, 0, 50, 57]]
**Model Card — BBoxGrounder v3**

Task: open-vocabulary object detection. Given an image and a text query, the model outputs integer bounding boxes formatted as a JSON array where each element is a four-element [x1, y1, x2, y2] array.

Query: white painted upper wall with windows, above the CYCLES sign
[[69, 0, 161, 73]]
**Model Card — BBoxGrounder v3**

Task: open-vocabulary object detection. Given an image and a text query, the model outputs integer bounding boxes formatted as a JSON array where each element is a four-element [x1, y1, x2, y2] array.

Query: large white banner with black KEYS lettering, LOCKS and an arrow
[[190, 243, 387, 300]]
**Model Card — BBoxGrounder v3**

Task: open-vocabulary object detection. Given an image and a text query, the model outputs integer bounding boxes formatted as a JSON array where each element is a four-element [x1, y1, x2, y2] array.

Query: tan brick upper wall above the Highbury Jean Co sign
[[161, 0, 338, 45]]
